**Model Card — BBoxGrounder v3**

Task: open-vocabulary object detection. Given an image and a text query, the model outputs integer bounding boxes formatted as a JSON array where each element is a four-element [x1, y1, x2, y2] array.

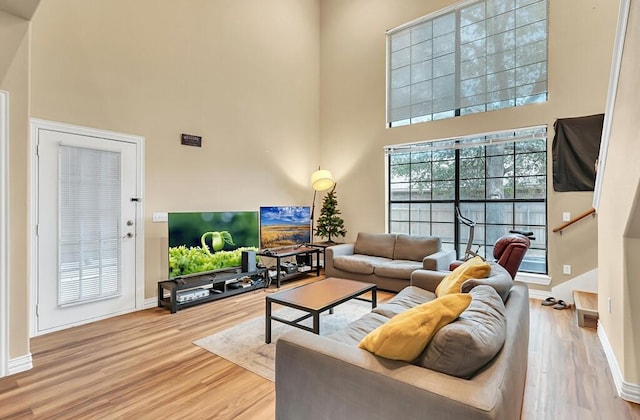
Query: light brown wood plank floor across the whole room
[[0, 278, 640, 420]]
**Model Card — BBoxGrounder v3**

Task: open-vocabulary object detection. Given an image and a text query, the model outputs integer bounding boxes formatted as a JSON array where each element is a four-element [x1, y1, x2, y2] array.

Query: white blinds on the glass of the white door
[[58, 145, 121, 306]]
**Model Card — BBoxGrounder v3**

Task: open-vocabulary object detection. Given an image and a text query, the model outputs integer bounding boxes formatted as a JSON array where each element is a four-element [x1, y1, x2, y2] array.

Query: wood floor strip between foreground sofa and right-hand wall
[[522, 299, 640, 420]]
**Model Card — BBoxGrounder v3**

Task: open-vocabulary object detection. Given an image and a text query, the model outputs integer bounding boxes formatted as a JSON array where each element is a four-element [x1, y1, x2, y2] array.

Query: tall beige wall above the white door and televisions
[[31, 0, 320, 298]]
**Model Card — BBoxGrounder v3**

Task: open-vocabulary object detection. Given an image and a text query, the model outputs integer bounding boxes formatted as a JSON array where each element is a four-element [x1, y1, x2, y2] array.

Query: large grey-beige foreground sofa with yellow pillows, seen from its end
[[275, 264, 529, 420]]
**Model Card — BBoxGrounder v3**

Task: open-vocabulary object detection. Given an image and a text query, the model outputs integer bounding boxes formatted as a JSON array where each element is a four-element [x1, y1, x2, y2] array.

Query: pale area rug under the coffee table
[[193, 300, 371, 382]]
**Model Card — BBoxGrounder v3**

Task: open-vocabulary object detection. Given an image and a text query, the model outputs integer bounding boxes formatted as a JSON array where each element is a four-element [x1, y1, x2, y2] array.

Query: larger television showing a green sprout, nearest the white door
[[168, 211, 260, 279]]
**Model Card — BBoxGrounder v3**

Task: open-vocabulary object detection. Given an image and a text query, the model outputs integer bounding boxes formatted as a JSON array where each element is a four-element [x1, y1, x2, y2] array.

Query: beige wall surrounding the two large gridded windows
[[320, 0, 618, 285]]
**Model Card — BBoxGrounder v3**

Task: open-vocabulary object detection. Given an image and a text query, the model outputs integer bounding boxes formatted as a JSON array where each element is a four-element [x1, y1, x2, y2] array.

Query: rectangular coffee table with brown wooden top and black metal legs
[[264, 277, 377, 344]]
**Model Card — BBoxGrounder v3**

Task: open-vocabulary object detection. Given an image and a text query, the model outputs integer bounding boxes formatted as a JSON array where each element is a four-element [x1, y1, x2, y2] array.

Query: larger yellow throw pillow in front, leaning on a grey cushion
[[358, 293, 471, 362]]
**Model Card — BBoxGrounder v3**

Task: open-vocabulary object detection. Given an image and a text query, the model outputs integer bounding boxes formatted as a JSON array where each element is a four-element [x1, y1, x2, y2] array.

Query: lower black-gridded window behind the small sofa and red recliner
[[386, 126, 547, 274]]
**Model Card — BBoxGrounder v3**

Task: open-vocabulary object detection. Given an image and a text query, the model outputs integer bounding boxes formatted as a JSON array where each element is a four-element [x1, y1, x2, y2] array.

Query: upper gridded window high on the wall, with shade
[[387, 0, 547, 127]]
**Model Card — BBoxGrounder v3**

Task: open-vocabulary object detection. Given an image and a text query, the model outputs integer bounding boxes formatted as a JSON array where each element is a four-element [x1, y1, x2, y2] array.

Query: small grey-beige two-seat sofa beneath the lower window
[[325, 232, 456, 292]]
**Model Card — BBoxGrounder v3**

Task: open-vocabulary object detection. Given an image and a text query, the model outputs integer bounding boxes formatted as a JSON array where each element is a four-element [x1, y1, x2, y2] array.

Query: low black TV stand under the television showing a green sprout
[[158, 268, 267, 314]]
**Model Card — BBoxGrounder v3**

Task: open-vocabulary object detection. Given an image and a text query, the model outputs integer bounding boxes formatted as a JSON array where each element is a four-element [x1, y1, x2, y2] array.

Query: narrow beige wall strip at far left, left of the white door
[[0, 11, 29, 358]]
